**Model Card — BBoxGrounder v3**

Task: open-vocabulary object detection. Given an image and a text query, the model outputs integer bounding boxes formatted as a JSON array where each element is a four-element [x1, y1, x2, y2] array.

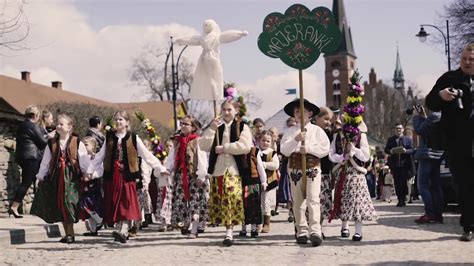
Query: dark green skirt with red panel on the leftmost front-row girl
[[31, 165, 79, 223]]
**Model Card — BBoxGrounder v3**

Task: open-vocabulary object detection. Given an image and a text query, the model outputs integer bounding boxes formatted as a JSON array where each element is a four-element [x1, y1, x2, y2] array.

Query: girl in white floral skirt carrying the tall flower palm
[[329, 122, 376, 241]]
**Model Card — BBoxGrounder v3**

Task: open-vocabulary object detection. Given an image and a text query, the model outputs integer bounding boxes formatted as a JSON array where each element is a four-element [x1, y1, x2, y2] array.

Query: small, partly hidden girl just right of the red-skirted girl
[[155, 139, 174, 232]]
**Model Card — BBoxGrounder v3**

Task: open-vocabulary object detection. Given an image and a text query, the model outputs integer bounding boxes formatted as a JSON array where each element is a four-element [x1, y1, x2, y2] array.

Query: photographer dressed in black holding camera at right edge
[[426, 43, 474, 241]]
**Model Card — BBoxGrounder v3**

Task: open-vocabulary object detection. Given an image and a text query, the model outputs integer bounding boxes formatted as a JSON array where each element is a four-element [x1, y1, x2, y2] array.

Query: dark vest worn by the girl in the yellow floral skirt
[[207, 120, 249, 176]]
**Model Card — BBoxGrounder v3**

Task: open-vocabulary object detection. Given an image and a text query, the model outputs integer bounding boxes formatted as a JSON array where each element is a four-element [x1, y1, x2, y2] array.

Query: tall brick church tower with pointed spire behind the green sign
[[324, 0, 357, 108]]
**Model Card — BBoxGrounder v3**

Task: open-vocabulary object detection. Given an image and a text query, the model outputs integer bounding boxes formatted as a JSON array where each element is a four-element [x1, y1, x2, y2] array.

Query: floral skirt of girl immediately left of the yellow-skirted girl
[[171, 172, 209, 225]]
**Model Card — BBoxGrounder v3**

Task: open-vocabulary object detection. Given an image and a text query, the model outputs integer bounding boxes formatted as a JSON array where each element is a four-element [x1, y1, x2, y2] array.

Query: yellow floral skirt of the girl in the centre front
[[209, 171, 244, 225]]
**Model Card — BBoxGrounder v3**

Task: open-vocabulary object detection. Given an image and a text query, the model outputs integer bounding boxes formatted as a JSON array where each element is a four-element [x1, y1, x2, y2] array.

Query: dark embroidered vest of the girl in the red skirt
[[104, 132, 140, 181]]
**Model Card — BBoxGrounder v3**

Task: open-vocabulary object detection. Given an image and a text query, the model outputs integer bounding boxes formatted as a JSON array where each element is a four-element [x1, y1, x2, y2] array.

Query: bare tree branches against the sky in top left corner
[[0, 0, 30, 51]]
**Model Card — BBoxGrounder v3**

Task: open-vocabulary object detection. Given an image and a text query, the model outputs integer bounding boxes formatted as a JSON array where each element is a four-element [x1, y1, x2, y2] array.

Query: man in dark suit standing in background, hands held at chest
[[385, 124, 414, 207]]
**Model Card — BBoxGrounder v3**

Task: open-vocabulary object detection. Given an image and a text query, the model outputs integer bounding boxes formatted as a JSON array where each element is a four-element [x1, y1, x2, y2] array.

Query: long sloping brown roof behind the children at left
[[0, 75, 184, 127]]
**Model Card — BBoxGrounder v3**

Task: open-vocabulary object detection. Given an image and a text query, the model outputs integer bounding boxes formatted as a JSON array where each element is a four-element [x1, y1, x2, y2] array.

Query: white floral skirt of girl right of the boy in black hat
[[336, 166, 377, 221]]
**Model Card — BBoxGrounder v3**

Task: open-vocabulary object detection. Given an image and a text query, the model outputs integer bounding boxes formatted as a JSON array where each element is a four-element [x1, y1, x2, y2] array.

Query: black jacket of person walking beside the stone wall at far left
[[15, 119, 48, 161]]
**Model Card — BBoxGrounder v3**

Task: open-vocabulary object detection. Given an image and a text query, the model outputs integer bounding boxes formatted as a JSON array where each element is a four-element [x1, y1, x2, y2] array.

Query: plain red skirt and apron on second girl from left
[[104, 161, 142, 226]]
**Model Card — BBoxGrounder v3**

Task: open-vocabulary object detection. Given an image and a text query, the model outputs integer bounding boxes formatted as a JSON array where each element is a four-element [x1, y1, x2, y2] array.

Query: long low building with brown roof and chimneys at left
[[0, 71, 186, 212]]
